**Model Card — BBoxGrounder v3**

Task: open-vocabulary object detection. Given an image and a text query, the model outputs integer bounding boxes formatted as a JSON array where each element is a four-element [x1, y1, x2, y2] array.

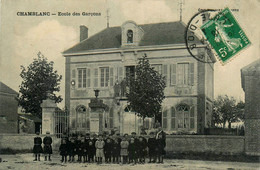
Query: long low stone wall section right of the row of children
[[166, 135, 245, 155]]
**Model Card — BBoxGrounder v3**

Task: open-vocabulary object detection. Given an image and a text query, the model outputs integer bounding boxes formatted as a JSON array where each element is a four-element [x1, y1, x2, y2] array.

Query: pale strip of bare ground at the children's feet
[[0, 154, 260, 170]]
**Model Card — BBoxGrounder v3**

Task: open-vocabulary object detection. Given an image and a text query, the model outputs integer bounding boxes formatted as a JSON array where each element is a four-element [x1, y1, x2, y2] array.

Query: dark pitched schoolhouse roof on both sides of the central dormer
[[63, 21, 201, 54]]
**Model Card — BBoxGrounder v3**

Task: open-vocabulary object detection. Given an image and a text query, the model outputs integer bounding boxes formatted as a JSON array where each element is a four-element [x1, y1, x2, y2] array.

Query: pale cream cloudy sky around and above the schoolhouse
[[0, 0, 260, 107]]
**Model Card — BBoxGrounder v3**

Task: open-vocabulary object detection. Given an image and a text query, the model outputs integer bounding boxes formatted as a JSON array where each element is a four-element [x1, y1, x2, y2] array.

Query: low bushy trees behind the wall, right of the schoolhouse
[[212, 95, 245, 128]]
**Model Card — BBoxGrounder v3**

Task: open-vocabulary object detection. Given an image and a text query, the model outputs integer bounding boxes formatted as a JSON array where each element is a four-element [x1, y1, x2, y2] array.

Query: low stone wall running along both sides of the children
[[0, 134, 245, 155]]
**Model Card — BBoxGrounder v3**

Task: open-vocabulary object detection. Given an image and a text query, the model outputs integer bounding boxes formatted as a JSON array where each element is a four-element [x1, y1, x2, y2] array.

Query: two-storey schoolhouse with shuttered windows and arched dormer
[[63, 21, 215, 133]]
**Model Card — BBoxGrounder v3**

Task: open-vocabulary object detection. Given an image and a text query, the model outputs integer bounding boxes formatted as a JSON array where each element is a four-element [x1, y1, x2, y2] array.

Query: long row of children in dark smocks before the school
[[59, 131, 166, 164]]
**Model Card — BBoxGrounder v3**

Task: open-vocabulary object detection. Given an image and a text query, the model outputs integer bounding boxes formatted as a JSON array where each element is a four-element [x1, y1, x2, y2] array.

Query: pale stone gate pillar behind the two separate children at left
[[41, 97, 57, 134]]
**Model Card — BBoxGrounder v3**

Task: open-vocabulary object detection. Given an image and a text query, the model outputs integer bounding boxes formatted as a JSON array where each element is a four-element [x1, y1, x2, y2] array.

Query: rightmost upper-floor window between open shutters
[[177, 63, 189, 85]]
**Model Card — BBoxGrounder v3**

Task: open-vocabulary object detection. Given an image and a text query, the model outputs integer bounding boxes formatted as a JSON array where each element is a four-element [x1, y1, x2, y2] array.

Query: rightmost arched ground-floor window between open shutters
[[177, 105, 189, 129]]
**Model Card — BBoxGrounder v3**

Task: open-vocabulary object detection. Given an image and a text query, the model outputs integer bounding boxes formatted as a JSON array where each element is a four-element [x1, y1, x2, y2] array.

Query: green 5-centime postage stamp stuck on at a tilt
[[200, 8, 251, 63]]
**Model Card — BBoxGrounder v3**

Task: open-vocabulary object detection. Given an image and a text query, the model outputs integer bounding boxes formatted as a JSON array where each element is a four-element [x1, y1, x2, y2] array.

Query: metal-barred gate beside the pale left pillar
[[53, 109, 69, 138]]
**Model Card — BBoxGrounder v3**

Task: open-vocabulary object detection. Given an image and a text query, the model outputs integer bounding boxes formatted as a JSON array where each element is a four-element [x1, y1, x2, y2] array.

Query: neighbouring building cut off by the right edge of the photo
[[241, 59, 260, 156]]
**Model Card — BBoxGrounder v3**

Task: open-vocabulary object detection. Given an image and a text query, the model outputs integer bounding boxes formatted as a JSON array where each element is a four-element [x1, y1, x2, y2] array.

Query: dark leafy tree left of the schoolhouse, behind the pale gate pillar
[[18, 52, 62, 118]]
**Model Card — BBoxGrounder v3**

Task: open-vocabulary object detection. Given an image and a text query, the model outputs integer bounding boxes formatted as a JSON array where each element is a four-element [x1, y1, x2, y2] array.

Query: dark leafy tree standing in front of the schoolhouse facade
[[127, 54, 166, 120]]
